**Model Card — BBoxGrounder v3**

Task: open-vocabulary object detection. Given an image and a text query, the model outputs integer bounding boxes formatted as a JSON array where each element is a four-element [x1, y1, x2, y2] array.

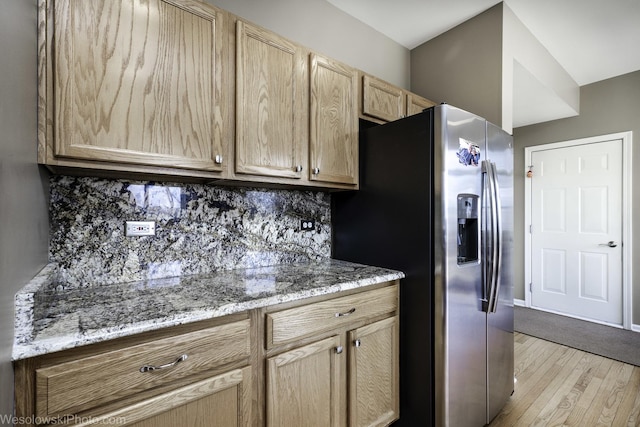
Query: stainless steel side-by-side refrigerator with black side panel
[[332, 105, 514, 427]]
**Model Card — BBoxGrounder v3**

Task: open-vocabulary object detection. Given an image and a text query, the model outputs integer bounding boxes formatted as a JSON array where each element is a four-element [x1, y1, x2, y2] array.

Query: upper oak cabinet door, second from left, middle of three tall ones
[[236, 21, 307, 178]]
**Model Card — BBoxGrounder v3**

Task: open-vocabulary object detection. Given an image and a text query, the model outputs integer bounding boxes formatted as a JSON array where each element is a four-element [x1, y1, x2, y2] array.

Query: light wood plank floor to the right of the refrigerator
[[489, 332, 640, 427]]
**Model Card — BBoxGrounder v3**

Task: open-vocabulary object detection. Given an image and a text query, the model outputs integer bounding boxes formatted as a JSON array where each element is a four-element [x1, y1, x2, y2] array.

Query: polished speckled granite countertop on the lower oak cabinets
[[12, 259, 404, 360]]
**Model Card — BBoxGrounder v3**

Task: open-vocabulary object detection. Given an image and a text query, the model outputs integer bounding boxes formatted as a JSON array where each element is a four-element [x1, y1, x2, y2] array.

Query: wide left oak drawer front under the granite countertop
[[36, 320, 250, 417]]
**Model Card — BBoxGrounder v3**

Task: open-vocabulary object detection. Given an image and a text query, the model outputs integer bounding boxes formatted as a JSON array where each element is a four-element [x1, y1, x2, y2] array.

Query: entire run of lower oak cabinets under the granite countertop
[[14, 281, 399, 427]]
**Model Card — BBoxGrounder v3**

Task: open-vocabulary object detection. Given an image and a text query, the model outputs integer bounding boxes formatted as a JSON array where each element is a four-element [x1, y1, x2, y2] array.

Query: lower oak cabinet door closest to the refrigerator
[[348, 316, 399, 427]]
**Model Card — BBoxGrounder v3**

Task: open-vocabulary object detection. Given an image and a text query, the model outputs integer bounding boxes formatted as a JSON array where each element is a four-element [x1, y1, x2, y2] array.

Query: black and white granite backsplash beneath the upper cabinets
[[49, 176, 331, 288]]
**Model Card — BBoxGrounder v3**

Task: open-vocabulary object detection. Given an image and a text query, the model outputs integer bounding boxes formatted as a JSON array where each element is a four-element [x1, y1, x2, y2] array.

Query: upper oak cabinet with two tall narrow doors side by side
[[235, 20, 358, 188]]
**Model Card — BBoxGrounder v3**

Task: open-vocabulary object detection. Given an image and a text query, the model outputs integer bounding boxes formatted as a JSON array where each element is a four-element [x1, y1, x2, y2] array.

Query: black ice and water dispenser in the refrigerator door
[[458, 194, 480, 265]]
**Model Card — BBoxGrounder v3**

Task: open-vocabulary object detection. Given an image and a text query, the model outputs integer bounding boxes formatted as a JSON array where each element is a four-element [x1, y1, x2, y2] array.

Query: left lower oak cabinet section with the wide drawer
[[14, 313, 255, 427]]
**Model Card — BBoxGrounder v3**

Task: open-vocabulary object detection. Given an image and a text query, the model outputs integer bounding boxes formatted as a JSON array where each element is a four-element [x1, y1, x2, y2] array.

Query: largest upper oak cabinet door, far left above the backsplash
[[51, 0, 222, 171]]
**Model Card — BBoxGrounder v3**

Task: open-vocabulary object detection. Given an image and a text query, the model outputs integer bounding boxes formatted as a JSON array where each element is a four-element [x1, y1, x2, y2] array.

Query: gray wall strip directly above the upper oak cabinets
[[206, 0, 410, 89]]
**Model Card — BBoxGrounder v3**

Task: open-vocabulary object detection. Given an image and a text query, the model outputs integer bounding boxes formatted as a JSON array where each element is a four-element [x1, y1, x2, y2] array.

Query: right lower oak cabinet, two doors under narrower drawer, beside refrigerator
[[265, 285, 399, 427]]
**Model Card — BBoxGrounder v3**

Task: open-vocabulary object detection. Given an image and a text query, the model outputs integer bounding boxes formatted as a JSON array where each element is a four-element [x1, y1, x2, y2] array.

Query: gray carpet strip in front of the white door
[[514, 307, 640, 366]]
